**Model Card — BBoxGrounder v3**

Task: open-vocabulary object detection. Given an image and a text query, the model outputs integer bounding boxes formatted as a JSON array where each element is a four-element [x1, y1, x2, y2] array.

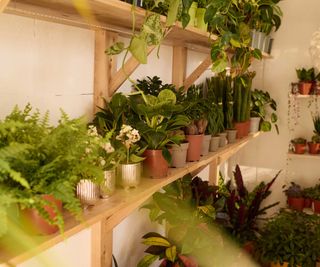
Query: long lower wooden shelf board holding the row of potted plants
[[0, 133, 260, 265]]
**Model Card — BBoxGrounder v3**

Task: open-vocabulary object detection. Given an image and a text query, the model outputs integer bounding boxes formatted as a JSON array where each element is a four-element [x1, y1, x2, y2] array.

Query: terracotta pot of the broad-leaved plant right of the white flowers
[[143, 149, 169, 178]]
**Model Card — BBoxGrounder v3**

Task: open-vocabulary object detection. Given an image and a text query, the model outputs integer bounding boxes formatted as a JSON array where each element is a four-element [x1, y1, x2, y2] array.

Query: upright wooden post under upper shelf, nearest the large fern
[[93, 30, 118, 113]]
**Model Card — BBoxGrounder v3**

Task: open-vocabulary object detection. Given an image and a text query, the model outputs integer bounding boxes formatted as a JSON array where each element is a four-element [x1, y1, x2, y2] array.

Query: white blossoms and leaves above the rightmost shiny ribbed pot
[[116, 124, 145, 164]]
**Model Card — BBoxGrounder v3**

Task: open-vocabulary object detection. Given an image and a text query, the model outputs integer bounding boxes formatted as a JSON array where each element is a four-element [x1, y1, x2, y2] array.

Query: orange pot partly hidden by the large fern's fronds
[[22, 195, 62, 235]]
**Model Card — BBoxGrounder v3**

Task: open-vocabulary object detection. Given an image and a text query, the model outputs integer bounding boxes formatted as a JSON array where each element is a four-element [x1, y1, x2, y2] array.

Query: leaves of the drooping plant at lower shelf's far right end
[[250, 89, 279, 134]]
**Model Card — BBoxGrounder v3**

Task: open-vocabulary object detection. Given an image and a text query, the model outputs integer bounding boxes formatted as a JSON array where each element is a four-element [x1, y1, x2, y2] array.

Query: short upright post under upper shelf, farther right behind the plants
[[172, 46, 187, 89]]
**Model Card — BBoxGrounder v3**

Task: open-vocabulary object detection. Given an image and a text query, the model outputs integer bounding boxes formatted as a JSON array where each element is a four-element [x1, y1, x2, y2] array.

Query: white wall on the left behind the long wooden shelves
[[0, 11, 212, 267]]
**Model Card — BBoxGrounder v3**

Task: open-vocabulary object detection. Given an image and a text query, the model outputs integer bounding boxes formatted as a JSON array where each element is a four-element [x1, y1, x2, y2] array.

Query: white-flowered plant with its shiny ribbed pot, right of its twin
[[116, 124, 145, 189]]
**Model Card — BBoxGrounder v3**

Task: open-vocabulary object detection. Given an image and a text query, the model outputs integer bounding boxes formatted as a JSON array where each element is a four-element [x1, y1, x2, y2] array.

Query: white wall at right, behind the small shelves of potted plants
[[238, 0, 320, 203]]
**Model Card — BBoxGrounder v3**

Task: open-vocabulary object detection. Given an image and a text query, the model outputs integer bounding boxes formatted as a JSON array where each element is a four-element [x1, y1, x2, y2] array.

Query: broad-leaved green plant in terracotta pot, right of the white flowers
[[129, 89, 189, 178]]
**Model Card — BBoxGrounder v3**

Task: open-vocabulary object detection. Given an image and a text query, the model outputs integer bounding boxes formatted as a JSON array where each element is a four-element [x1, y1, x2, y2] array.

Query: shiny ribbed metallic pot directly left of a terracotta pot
[[117, 162, 142, 190]]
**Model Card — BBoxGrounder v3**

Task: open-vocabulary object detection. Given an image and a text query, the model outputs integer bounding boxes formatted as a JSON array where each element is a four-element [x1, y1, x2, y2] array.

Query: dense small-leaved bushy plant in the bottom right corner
[[258, 211, 320, 267]]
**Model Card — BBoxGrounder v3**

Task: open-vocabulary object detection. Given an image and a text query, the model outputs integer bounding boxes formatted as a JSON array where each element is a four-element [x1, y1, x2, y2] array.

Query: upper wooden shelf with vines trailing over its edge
[[4, 0, 216, 52]]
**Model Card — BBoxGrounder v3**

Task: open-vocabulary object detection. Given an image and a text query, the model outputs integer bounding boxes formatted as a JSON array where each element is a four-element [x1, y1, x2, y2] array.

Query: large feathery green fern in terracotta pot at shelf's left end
[[0, 104, 103, 237]]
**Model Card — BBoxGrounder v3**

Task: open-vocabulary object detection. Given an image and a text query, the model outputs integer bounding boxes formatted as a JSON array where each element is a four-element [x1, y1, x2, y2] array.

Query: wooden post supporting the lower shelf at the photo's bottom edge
[[91, 219, 112, 267]]
